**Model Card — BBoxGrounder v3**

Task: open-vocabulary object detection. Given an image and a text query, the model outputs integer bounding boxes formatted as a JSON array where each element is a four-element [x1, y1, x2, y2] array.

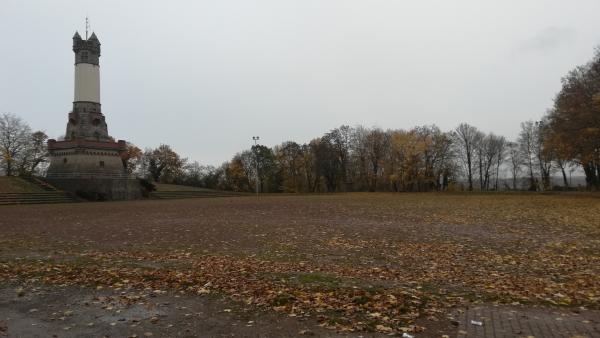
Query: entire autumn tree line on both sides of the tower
[[0, 49, 600, 193]]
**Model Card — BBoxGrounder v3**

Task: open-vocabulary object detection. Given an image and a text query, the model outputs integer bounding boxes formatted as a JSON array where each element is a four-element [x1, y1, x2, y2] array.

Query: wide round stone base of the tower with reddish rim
[[46, 140, 146, 201]]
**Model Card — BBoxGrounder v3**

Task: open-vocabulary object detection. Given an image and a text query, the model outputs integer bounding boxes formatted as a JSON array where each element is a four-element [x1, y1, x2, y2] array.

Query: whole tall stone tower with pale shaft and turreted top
[[46, 32, 141, 199]]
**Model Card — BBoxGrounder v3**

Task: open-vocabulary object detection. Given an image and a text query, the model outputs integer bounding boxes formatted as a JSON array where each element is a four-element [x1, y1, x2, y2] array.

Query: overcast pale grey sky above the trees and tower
[[0, 0, 600, 165]]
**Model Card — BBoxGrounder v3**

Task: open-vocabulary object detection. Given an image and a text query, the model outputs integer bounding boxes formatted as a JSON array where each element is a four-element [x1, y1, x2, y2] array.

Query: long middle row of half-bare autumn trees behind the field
[[216, 121, 580, 192]]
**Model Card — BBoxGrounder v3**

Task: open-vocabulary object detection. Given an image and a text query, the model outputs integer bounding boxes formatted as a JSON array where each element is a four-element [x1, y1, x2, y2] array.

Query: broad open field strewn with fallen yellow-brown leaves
[[0, 194, 600, 333]]
